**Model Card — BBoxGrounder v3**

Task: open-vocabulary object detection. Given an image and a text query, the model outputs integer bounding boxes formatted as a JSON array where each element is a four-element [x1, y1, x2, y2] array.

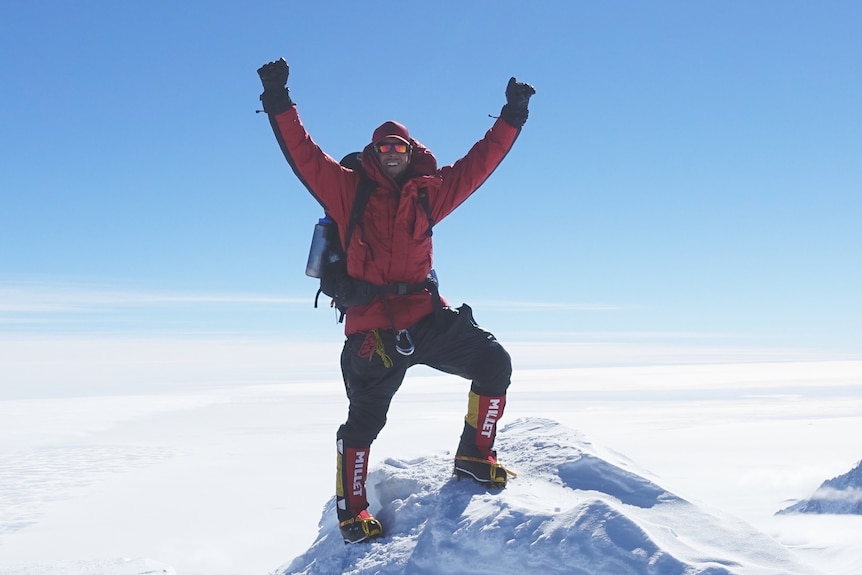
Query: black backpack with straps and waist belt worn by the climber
[[306, 152, 440, 323]]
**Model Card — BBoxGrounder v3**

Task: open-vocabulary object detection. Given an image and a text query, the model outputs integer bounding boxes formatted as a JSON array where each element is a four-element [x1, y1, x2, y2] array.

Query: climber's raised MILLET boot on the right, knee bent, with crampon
[[455, 391, 515, 489]]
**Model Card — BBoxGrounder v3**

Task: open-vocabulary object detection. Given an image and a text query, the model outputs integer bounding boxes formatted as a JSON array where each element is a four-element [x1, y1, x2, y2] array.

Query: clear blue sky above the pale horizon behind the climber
[[0, 0, 862, 354]]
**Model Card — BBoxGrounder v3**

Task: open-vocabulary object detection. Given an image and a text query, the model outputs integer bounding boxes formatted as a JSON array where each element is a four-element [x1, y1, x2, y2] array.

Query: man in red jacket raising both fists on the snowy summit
[[258, 58, 535, 543]]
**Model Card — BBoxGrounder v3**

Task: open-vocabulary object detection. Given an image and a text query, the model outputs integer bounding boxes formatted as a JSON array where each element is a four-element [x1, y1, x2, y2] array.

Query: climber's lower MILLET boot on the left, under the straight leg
[[335, 439, 383, 543]]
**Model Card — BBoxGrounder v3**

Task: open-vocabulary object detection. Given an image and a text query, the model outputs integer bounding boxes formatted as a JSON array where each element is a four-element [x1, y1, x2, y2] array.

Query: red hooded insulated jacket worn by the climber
[[270, 106, 520, 335]]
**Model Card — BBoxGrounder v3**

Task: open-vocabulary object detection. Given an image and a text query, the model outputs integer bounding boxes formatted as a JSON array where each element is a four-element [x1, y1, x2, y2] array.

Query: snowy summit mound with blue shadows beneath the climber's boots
[[276, 418, 815, 575]]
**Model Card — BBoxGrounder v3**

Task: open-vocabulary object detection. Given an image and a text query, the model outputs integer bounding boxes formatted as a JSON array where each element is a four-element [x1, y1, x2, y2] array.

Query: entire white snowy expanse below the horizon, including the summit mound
[[0, 341, 862, 575]]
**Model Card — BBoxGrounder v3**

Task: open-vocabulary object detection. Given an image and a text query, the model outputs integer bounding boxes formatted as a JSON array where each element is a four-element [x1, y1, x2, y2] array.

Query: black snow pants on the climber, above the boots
[[337, 304, 512, 448]]
